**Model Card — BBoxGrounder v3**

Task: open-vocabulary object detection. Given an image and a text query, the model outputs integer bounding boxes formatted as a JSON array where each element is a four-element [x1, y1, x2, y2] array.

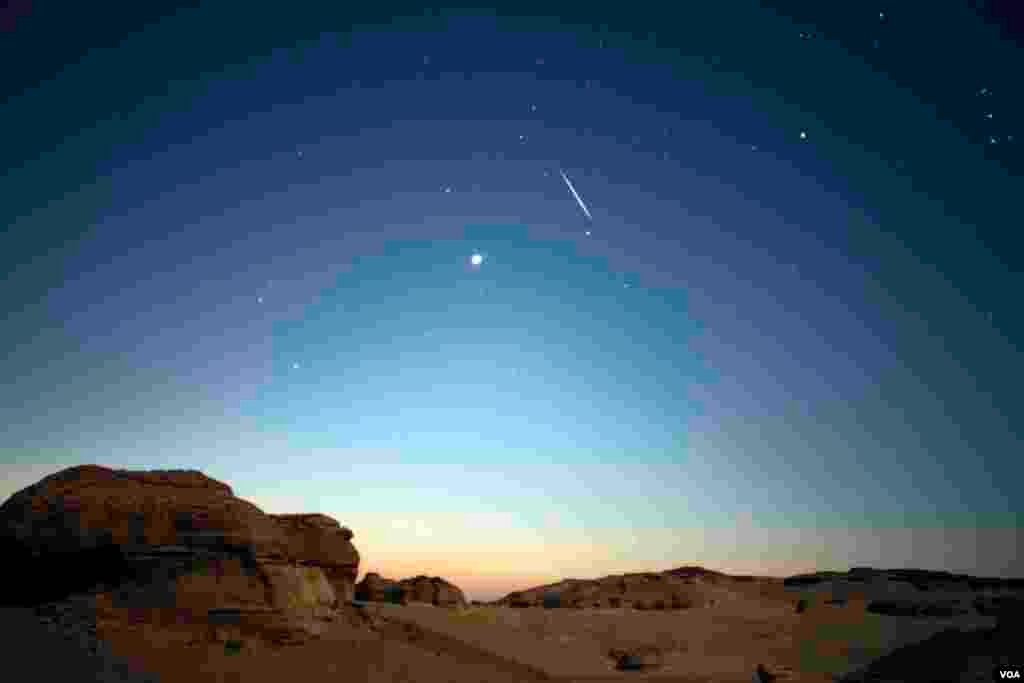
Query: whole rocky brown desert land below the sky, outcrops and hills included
[[6, 466, 1024, 683]]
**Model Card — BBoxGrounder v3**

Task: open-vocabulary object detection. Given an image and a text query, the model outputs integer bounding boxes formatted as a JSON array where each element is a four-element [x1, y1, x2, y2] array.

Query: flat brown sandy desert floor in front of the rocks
[[6, 585, 992, 683]]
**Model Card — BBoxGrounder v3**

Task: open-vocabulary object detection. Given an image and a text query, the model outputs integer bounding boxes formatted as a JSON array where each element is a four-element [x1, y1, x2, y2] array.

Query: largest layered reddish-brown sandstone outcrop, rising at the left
[[0, 465, 358, 642]]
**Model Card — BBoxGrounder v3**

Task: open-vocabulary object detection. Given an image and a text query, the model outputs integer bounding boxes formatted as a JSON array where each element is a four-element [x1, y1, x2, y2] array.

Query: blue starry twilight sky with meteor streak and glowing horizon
[[0, 0, 1024, 597]]
